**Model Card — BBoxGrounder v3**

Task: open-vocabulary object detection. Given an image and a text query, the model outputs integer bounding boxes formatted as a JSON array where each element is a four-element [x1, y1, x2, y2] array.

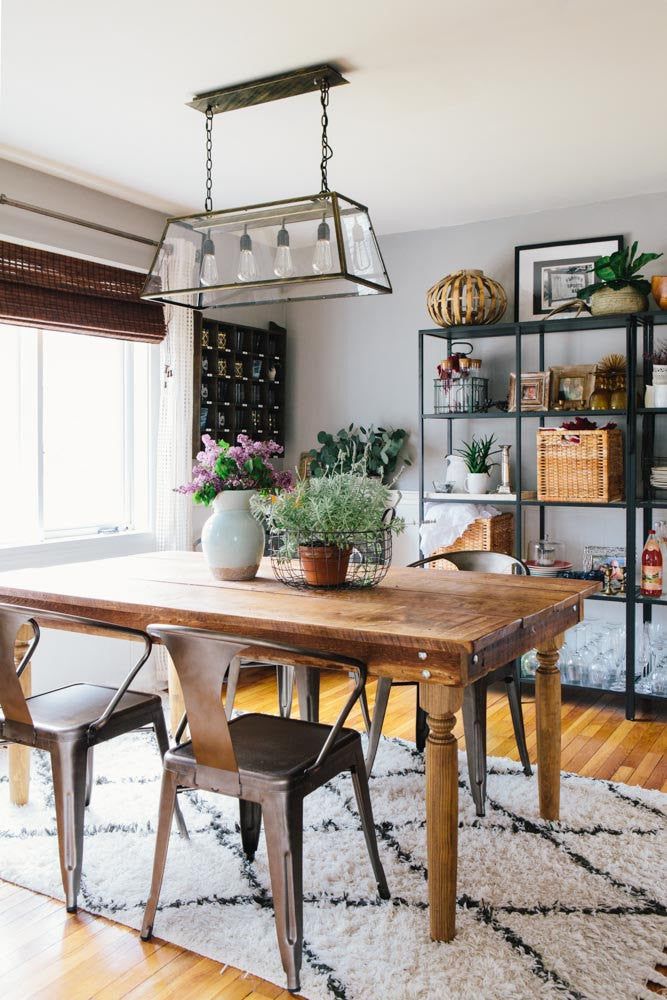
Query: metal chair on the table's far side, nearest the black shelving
[[366, 551, 533, 816]]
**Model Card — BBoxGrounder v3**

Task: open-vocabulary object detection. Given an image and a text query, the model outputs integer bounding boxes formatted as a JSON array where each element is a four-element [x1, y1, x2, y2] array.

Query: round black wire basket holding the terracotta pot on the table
[[269, 528, 391, 590]]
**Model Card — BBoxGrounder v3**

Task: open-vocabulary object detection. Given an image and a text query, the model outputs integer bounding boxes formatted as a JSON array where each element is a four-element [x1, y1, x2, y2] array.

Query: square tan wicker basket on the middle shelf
[[537, 427, 624, 503]]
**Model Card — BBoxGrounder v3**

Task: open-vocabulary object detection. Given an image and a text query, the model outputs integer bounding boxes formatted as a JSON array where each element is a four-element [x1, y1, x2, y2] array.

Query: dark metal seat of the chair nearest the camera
[[165, 713, 360, 778]]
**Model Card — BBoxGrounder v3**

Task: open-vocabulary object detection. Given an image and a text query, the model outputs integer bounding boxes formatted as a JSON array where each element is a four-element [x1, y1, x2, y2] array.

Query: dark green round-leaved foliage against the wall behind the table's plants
[[308, 424, 411, 484]]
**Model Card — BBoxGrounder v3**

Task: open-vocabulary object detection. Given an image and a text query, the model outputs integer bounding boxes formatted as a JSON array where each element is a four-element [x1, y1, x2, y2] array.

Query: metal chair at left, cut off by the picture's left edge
[[0, 604, 187, 913]]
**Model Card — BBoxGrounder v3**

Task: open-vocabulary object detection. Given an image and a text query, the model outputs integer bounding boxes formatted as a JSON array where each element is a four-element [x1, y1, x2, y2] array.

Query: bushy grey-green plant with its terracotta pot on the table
[[252, 463, 405, 587]]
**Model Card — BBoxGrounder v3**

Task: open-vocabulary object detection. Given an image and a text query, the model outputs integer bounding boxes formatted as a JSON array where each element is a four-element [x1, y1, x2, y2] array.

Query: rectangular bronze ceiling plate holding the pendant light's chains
[[188, 63, 349, 115]]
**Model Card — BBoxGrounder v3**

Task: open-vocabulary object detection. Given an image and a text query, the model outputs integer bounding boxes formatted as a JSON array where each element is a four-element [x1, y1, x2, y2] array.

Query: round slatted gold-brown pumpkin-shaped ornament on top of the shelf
[[426, 271, 507, 327]]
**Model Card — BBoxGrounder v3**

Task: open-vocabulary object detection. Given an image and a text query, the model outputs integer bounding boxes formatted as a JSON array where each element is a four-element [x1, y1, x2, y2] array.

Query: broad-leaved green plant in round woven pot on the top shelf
[[579, 240, 662, 316]]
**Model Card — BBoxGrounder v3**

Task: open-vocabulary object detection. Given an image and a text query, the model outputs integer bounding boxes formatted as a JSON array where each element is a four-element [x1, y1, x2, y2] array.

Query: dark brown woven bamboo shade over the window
[[0, 241, 166, 344]]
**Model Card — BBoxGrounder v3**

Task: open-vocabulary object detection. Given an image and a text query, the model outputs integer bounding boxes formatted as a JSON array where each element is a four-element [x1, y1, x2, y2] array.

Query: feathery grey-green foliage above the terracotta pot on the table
[[251, 467, 405, 545]]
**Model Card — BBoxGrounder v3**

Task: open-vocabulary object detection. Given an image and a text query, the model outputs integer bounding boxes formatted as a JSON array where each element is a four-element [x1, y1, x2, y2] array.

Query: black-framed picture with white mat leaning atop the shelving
[[514, 236, 623, 322]]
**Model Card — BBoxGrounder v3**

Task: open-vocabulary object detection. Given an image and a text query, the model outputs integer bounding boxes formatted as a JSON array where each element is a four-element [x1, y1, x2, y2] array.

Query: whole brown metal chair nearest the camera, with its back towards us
[[141, 625, 389, 991]]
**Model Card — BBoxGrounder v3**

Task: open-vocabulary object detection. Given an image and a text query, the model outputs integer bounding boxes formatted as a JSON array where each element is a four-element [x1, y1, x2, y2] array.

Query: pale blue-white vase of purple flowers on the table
[[176, 434, 293, 580]]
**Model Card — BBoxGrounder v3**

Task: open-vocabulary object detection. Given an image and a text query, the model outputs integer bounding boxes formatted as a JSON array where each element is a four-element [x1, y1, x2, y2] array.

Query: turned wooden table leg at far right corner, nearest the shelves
[[535, 635, 563, 819]]
